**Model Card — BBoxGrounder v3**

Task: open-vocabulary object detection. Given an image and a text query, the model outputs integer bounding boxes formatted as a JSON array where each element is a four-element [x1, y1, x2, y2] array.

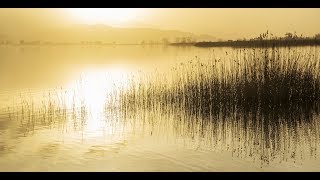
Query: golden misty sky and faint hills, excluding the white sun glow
[[0, 8, 320, 43]]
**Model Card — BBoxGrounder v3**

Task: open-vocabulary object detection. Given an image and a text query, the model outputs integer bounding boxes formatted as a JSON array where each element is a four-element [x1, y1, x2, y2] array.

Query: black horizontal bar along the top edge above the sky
[[0, 0, 320, 8]]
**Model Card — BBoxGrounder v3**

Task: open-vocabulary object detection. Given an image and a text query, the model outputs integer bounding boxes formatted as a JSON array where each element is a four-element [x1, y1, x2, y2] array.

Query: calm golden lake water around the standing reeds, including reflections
[[0, 46, 320, 171]]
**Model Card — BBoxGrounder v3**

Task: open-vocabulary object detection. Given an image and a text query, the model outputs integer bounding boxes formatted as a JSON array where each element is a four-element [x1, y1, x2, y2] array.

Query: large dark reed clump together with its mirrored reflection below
[[115, 47, 320, 163]]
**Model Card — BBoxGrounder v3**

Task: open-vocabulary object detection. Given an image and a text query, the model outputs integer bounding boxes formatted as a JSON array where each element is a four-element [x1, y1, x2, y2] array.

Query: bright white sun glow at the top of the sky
[[68, 8, 142, 25]]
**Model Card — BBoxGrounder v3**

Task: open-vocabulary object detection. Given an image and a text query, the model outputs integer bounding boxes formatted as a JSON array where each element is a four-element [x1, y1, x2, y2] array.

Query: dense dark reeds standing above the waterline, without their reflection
[[120, 48, 320, 119]]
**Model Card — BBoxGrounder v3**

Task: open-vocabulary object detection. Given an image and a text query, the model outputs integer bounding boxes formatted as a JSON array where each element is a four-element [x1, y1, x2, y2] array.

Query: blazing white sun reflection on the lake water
[[66, 68, 127, 136]]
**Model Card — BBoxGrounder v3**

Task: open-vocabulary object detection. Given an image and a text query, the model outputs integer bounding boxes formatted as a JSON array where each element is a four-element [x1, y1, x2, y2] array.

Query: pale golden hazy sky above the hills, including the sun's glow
[[0, 8, 320, 39]]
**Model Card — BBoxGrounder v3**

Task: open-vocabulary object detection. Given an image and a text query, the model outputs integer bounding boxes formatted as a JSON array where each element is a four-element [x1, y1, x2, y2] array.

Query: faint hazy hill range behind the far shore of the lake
[[0, 25, 216, 43]]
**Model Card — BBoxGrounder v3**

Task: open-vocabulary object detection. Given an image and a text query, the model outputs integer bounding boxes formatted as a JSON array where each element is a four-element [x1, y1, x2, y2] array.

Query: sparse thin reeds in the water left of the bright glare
[[8, 89, 87, 134]]
